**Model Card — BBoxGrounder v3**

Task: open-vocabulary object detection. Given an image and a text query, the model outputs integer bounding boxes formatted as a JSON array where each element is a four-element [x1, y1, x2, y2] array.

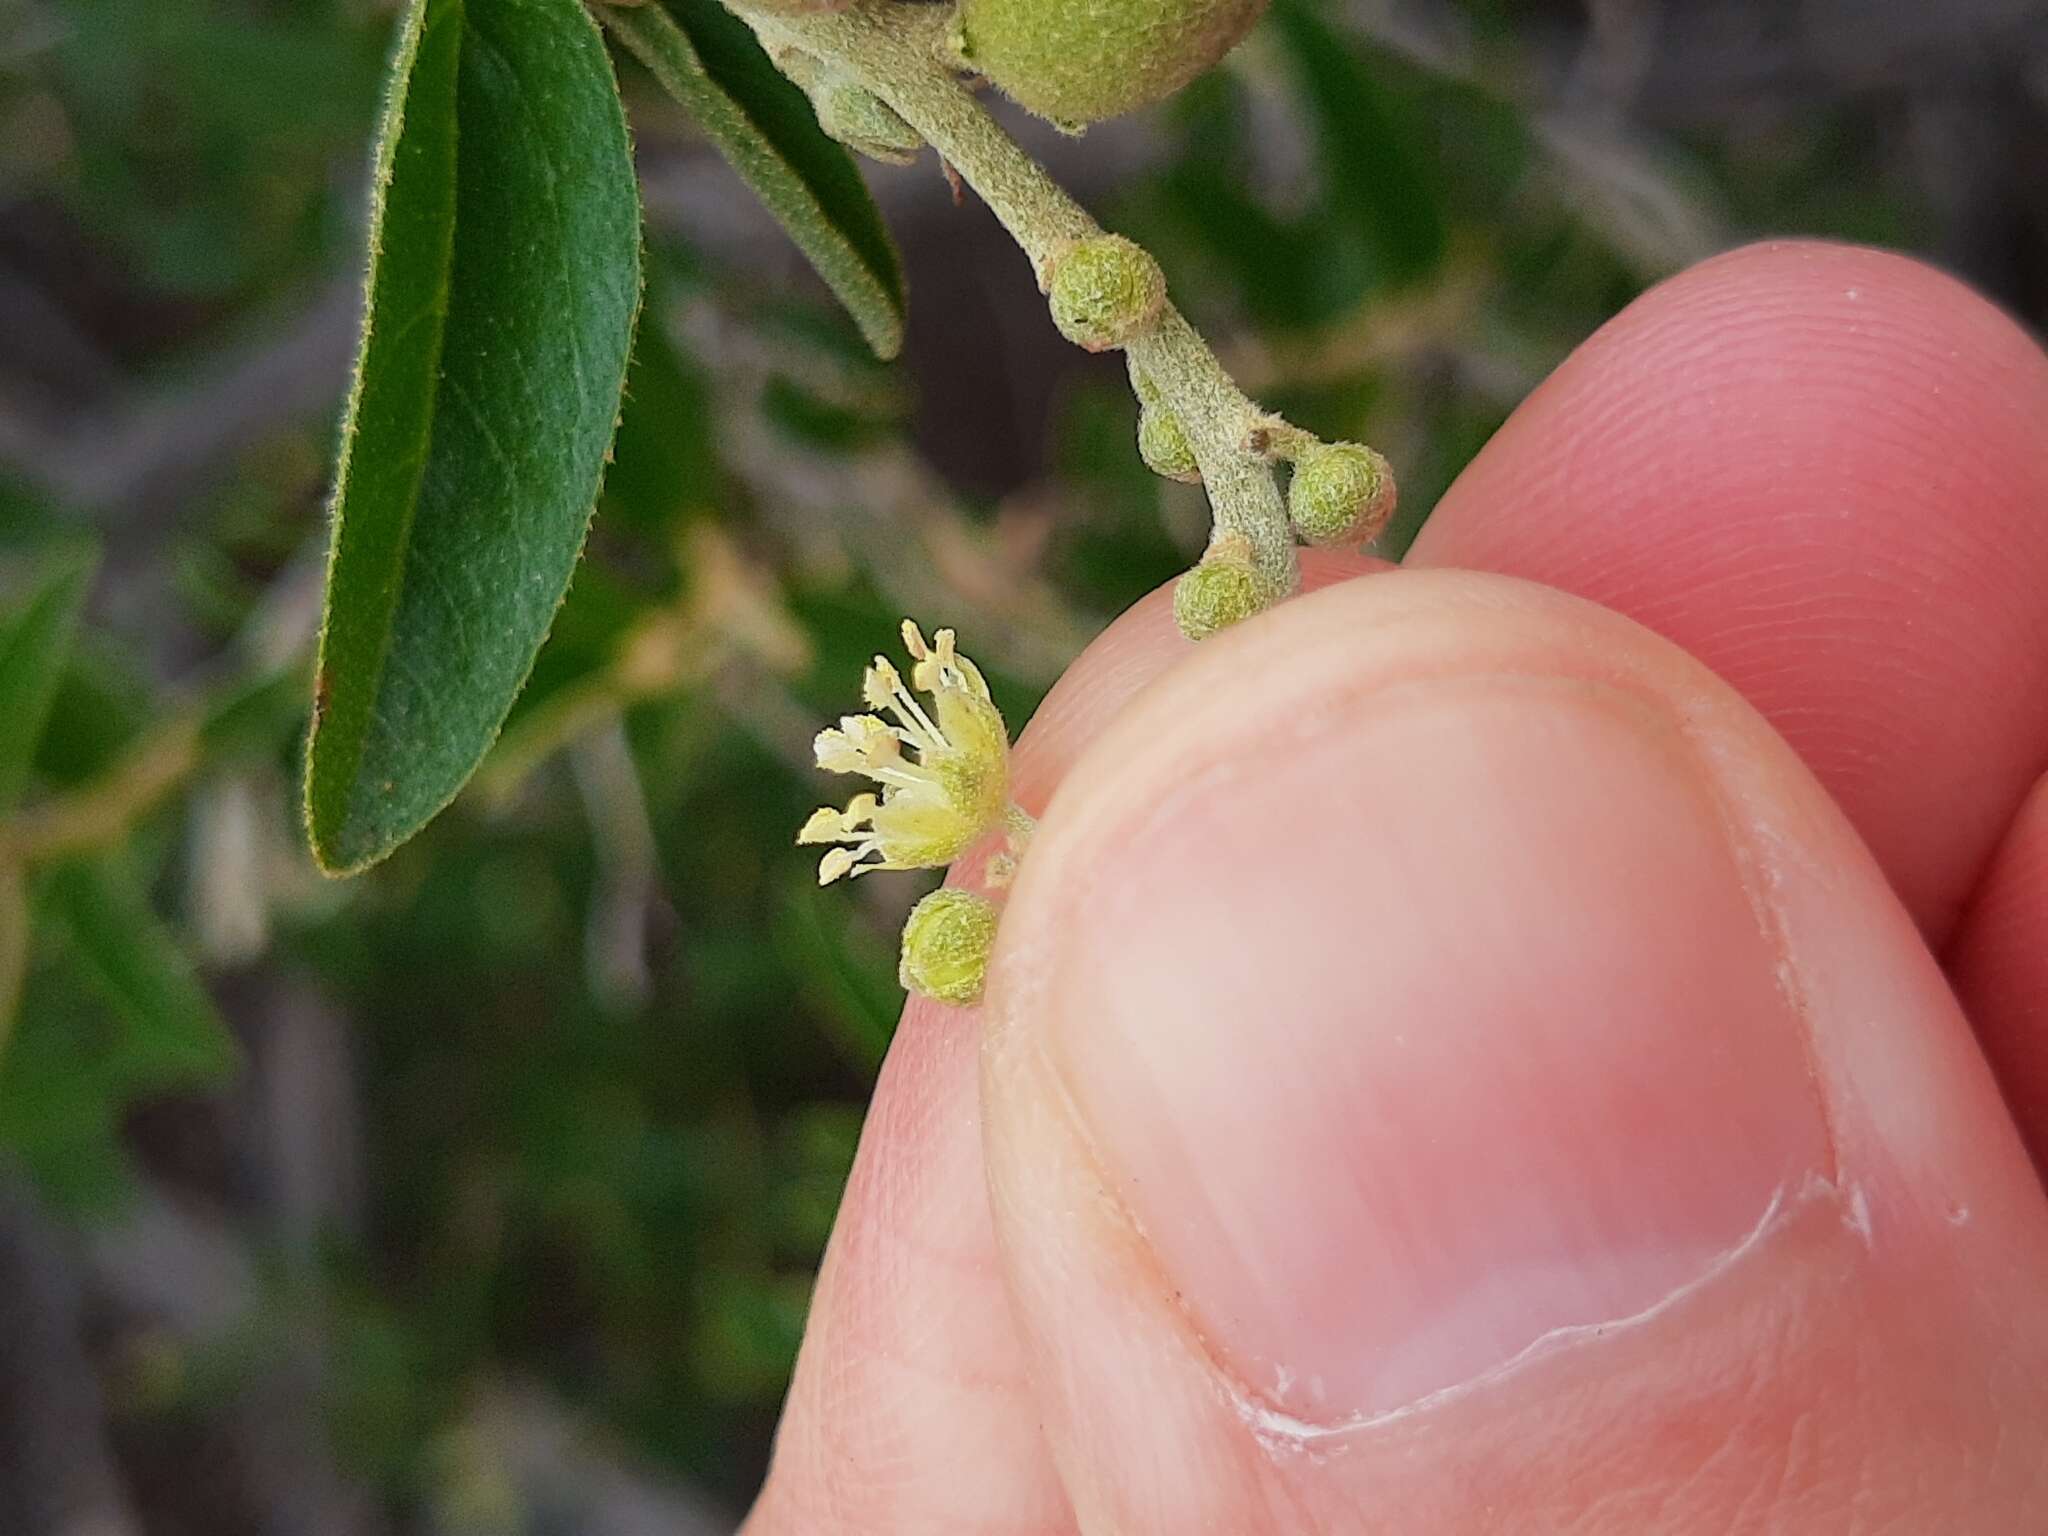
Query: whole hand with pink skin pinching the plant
[[748, 246, 2048, 1536]]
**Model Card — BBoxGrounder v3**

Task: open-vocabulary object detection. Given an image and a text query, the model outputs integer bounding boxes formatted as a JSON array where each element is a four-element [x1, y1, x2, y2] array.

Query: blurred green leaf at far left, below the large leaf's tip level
[[43, 856, 242, 1096]]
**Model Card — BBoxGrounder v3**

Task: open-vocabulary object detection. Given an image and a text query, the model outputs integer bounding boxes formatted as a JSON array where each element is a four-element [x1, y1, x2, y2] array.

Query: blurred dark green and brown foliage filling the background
[[0, 0, 2048, 1536]]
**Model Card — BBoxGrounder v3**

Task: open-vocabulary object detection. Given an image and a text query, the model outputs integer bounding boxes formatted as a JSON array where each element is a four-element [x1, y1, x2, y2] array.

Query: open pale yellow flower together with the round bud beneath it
[[797, 618, 1030, 1004]]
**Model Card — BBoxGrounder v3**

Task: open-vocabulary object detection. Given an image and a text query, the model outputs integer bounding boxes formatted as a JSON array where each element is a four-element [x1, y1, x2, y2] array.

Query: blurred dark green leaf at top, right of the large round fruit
[[1274, 0, 1448, 285]]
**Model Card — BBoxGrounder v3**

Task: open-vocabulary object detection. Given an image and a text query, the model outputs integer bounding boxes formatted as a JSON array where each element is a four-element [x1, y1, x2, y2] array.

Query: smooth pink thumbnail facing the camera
[[1049, 678, 1829, 1423]]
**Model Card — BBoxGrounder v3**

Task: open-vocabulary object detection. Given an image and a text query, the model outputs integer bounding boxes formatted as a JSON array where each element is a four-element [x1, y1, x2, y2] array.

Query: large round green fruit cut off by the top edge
[[954, 0, 1266, 125]]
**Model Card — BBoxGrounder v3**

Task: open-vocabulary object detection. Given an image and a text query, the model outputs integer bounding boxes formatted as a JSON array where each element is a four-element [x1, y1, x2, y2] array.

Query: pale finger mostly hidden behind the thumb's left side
[[745, 551, 1386, 1536]]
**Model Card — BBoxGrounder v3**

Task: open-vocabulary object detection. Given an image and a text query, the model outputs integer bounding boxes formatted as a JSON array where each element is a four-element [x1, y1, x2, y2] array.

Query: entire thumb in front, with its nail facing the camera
[[981, 573, 2048, 1536]]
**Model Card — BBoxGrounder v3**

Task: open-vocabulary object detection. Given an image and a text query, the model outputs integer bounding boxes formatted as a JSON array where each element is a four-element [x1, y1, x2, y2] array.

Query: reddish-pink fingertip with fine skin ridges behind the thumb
[[1409, 242, 2048, 946]]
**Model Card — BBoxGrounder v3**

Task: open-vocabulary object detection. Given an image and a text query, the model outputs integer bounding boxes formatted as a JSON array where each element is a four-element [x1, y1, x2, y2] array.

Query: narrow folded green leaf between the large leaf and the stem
[[604, 0, 903, 358]]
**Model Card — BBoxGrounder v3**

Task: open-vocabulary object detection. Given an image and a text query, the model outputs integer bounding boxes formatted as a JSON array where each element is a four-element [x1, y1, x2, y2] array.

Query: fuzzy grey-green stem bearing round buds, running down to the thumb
[[735, 0, 1298, 600]]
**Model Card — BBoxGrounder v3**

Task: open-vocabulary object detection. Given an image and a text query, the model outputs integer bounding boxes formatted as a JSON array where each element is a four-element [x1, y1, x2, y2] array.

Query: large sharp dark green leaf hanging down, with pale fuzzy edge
[[307, 0, 639, 874]]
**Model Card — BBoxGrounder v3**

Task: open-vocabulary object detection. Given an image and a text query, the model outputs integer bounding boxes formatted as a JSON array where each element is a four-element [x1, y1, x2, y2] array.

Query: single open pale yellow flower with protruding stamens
[[797, 618, 1010, 885]]
